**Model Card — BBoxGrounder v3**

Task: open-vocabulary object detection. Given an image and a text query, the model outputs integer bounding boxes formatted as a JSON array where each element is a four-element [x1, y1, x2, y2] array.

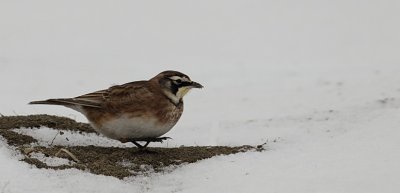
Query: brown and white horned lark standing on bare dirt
[[29, 71, 203, 148]]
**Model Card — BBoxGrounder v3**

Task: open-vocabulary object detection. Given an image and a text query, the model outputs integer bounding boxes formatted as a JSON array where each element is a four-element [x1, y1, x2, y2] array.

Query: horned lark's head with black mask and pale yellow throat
[[152, 71, 203, 104]]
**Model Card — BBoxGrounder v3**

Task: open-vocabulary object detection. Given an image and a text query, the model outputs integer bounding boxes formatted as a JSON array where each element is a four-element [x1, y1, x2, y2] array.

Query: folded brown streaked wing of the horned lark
[[74, 81, 154, 107]]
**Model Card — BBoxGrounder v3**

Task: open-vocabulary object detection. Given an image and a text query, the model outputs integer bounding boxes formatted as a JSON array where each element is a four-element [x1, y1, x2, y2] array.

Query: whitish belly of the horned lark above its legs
[[93, 117, 175, 140]]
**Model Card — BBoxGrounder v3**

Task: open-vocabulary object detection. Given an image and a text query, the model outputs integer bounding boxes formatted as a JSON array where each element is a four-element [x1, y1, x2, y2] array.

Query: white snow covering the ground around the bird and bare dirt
[[0, 0, 400, 193]]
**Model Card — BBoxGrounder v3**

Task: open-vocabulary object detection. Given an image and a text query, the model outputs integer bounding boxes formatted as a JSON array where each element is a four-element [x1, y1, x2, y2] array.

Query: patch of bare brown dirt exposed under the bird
[[0, 115, 264, 178]]
